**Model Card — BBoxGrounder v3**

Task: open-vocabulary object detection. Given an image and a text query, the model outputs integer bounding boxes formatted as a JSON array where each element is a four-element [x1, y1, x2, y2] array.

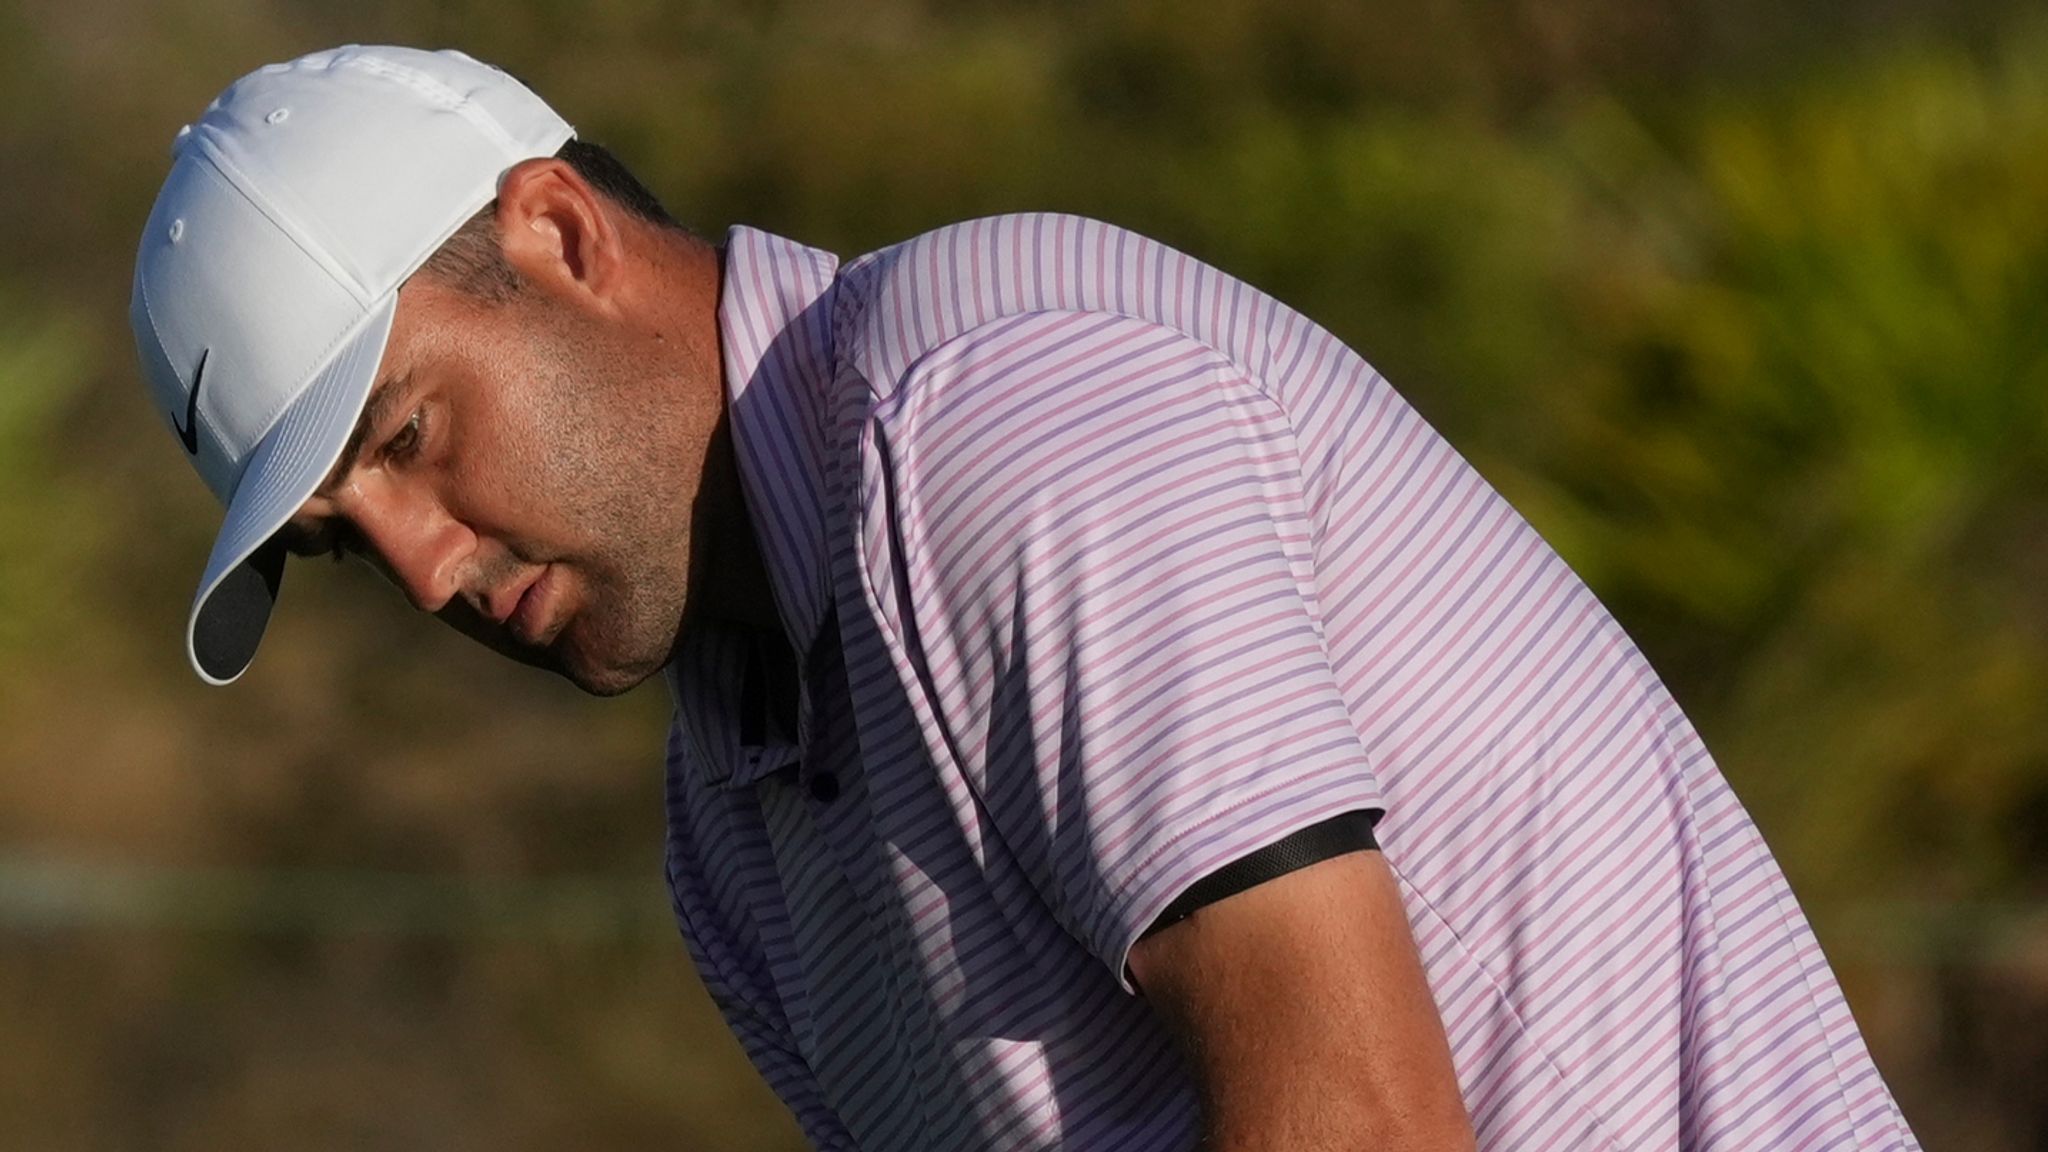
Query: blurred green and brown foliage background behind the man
[[0, 0, 2048, 1152]]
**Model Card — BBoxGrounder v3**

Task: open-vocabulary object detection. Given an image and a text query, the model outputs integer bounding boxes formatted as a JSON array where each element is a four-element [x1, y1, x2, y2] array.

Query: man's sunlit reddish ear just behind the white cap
[[498, 156, 625, 312]]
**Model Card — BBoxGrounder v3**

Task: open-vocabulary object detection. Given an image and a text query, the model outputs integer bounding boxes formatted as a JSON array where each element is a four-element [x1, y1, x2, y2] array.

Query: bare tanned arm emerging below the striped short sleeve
[[1130, 851, 1475, 1152]]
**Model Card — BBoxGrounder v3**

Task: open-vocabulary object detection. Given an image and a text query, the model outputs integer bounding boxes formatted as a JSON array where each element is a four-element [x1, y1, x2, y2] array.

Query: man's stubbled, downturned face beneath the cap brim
[[287, 268, 717, 695]]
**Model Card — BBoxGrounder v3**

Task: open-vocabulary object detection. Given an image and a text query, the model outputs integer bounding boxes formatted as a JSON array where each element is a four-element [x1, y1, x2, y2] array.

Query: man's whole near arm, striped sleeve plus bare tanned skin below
[[880, 314, 1473, 1152]]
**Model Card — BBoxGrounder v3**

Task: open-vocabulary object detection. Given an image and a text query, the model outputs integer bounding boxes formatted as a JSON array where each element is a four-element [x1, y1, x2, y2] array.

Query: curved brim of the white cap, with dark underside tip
[[184, 293, 397, 685]]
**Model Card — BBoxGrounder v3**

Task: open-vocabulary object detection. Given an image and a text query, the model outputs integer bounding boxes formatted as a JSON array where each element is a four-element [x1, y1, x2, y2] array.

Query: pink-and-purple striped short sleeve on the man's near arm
[[860, 312, 1382, 988]]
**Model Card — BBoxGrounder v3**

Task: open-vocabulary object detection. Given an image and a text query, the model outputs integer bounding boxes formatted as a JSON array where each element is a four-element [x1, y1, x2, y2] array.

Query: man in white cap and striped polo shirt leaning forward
[[133, 49, 1915, 1150]]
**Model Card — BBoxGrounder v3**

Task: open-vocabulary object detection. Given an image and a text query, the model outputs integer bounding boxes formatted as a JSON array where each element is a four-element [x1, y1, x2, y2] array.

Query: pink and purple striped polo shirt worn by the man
[[668, 215, 1915, 1152]]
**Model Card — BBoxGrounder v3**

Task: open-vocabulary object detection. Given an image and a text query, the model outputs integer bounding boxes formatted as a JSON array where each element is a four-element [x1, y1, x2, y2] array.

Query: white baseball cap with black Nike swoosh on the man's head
[[129, 45, 575, 685]]
